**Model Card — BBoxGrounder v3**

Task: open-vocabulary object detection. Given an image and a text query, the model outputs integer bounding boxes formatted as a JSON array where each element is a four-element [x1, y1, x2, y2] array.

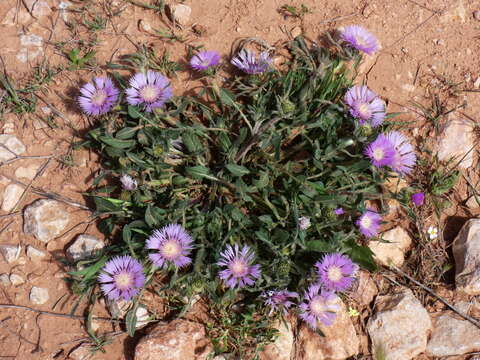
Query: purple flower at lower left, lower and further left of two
[[98, 255, 145, 301]]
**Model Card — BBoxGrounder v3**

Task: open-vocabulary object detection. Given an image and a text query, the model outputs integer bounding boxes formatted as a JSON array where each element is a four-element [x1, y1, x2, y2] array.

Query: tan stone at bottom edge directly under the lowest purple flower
[[295, 299, 360, 360]]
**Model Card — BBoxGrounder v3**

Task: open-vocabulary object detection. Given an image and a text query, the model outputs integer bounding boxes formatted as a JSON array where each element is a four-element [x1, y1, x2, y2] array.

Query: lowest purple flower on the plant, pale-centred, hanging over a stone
[[299, 284, 340, 330]]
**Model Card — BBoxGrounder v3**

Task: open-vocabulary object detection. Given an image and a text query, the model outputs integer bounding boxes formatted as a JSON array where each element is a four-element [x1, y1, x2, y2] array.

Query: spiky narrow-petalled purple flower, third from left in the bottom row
[[217, 244, 262, 288]]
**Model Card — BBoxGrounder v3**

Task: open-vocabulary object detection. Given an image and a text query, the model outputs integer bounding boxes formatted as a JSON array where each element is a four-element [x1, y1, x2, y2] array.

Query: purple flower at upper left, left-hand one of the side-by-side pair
[[78, 77, 119, 116]]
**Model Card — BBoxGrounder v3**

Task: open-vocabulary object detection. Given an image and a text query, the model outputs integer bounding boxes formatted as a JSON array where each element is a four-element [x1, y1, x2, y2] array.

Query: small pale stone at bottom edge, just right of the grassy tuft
[[260, 320, 294, 360]]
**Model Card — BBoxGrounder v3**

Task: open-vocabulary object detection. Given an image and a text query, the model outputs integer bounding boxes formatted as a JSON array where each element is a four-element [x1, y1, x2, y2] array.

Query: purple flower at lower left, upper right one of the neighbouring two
[[146, 224, 193, 268]]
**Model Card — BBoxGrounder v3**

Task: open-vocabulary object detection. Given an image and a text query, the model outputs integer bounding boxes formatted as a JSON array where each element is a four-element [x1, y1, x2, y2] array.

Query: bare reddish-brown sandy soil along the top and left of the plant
[[0, 0, 480, 360]]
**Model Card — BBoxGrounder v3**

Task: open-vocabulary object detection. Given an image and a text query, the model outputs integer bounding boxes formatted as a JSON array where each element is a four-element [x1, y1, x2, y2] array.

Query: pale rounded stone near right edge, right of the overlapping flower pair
[[438, 119, 475, 169]]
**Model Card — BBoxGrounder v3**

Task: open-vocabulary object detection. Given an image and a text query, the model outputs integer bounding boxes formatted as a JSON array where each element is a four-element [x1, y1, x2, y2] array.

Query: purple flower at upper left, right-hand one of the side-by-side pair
[[125, 70, 173, 112]]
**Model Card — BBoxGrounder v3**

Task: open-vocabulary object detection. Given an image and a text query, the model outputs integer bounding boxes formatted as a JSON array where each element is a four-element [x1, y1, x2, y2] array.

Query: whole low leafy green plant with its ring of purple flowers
[[70, 27, 415, 353]]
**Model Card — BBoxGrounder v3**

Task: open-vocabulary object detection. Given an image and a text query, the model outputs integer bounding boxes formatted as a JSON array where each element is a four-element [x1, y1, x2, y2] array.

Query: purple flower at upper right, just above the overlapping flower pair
[[344, 85, 385, 127]]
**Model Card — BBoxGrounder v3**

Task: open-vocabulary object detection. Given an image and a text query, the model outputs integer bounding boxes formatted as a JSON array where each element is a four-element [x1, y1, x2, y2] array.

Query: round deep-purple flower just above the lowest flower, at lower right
[[315, 253, 358, 291]]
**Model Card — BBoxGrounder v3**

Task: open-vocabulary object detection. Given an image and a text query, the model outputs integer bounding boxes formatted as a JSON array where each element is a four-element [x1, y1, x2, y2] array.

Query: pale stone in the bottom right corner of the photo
[[427, 313, 480, 357]]
